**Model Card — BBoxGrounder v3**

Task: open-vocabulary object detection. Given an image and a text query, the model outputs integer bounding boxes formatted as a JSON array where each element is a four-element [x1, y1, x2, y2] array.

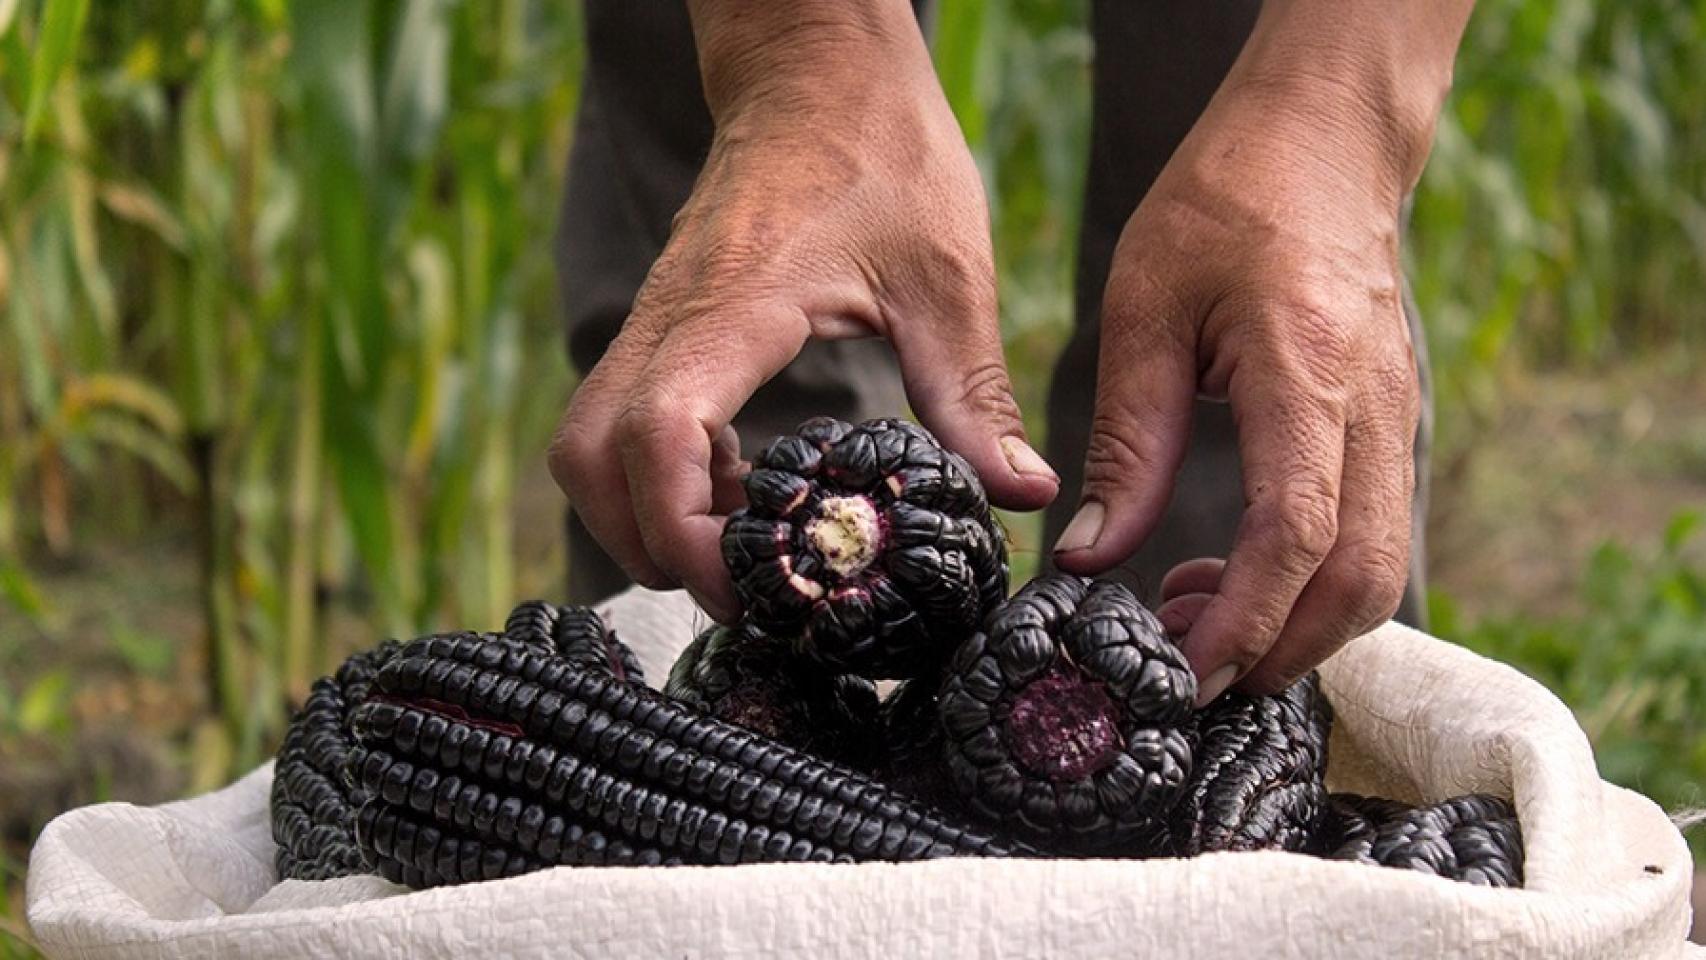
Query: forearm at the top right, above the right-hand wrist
[[1225, 0, 1474, 194]]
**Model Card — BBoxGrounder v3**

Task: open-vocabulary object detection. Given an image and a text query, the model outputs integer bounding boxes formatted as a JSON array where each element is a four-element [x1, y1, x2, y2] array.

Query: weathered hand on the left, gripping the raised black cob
[[549, 3, 1059, 621]]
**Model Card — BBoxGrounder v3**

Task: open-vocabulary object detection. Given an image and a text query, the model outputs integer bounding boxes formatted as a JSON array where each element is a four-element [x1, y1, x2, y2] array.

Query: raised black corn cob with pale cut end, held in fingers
[[722, 418, 1007, 679]]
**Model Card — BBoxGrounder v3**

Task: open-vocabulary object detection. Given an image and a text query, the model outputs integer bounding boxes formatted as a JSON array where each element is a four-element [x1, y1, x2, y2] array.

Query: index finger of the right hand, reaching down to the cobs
[[1181, 361, 1346, 704]]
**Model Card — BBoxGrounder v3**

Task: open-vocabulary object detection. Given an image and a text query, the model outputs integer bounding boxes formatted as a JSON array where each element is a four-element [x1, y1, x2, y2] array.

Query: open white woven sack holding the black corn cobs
[[27, 592, 1706, 960]]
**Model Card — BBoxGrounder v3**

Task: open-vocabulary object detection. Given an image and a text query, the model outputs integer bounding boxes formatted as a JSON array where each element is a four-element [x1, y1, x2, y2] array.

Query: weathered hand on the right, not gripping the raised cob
[[1056, 73, 1426, 703]]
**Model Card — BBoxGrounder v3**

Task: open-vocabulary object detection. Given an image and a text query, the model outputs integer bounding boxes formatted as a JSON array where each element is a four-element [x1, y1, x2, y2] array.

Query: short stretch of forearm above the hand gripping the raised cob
[[688, 0, 930, 124]]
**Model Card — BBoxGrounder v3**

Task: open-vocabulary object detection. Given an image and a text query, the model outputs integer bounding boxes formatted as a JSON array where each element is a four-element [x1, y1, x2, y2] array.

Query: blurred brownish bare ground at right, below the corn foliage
[[1428, 360, 1706, 617]]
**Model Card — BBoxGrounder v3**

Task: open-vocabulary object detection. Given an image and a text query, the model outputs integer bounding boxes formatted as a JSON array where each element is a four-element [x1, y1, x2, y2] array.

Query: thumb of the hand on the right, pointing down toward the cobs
[[1054, 268, 1196, 575]]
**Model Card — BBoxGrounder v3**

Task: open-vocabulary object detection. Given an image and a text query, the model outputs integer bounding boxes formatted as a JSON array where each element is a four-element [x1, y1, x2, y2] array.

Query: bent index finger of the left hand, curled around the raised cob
[[616, 307, 807, 622]]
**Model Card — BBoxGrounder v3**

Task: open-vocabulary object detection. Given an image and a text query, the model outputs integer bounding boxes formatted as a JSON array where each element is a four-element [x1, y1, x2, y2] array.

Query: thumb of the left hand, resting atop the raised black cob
[[892, 281, 1061, 510]]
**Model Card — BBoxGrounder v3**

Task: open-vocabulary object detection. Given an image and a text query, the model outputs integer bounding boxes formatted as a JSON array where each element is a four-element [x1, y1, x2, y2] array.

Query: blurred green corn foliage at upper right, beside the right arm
[[1407, 0, 1706, 447]]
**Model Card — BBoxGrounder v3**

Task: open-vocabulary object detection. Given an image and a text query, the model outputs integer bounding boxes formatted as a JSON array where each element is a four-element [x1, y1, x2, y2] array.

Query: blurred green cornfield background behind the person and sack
[[0, 0, 1706, 958]]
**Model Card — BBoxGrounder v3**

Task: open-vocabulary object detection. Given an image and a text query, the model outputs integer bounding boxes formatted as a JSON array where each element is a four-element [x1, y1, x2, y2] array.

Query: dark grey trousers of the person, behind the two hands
[[558, 0, 1431, 622]]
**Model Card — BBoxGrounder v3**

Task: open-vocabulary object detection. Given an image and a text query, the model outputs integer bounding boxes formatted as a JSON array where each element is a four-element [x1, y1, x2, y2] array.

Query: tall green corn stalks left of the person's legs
[[0, 0, 578, 762]]
